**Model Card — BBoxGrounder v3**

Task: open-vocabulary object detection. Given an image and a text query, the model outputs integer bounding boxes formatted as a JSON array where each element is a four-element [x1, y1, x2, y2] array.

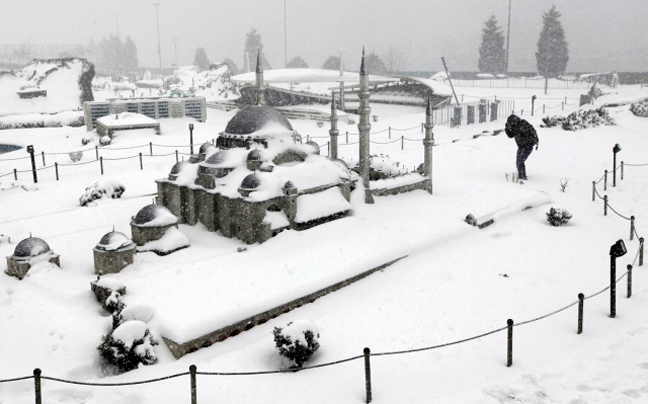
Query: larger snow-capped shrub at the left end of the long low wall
[[97, 321, 158, 372]]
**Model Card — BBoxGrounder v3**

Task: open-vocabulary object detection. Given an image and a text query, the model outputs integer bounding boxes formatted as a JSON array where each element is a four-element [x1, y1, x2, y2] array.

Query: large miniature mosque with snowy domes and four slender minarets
[[154, 50, 434, 244]]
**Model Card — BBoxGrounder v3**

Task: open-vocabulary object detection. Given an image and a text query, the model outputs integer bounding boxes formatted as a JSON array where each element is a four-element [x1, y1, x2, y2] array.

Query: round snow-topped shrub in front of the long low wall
[[272, 320, 319, 368]]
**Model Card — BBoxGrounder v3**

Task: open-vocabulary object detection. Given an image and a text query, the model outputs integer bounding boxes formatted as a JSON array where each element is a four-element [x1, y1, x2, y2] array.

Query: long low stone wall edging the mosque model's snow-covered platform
[[162, 256, 405, 359]]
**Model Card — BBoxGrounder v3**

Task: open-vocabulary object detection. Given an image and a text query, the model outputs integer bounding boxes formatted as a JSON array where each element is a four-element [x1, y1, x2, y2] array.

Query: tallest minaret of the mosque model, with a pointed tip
[[358, 47, 374, 203]]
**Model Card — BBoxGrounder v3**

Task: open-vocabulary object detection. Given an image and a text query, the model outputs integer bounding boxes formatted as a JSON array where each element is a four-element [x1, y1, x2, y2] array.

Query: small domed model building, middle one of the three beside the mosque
[[92, 231, 135, 274]]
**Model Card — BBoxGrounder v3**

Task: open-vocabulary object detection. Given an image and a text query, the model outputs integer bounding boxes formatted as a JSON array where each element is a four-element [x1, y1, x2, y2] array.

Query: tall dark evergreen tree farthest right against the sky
[[536, 6, 569, 79]]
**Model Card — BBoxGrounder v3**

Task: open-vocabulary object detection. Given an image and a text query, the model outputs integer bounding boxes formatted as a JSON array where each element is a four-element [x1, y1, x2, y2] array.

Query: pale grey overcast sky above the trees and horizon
[[5, 0, 648, 72]]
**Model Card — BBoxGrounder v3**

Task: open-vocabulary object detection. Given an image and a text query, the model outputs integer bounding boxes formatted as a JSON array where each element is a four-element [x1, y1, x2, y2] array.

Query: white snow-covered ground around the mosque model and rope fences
[[0, 86, 648, 403]]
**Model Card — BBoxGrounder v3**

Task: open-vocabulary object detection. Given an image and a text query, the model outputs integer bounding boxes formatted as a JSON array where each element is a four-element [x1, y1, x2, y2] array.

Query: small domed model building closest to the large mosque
[[130, 204, 189, 255]]
